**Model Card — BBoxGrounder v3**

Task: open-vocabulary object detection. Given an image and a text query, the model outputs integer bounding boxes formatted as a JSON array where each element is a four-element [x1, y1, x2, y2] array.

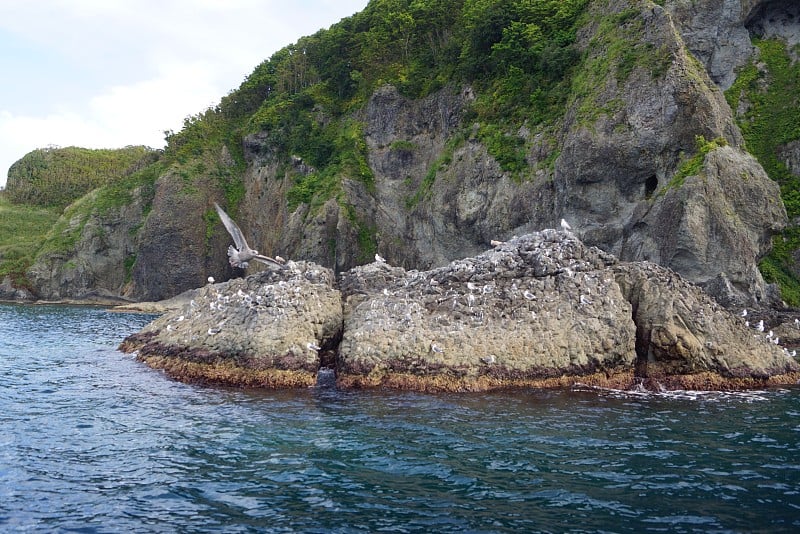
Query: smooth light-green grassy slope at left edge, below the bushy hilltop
[[0, 193, 60, 287]]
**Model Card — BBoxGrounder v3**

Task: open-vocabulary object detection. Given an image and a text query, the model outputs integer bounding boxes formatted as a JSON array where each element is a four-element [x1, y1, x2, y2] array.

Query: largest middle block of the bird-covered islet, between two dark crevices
[[337, 230, 635, 389]]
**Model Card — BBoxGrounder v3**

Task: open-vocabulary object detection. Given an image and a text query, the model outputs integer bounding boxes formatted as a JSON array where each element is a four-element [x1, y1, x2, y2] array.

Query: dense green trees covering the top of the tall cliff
[[177, 0, 588, 209]]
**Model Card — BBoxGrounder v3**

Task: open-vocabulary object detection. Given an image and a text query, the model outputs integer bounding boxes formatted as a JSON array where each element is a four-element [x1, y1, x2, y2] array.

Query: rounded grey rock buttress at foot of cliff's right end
[[622, 146, 786, 308]]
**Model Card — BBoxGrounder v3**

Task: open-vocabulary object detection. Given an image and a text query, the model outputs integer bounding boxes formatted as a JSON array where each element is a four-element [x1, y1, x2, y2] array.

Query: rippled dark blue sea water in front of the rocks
[[0, 305, 800, 532]]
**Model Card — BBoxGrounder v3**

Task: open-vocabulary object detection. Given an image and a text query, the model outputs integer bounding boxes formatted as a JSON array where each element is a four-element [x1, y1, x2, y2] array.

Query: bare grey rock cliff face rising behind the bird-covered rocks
[[21, 0, 800, 306]]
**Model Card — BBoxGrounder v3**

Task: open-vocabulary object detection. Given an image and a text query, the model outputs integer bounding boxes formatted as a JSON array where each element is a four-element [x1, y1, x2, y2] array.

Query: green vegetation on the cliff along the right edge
[[725, 39, 800, 306]]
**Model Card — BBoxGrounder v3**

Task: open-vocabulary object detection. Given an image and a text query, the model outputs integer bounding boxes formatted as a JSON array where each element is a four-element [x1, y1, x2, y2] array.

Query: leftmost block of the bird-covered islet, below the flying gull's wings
[[125, 262, 342, 387]]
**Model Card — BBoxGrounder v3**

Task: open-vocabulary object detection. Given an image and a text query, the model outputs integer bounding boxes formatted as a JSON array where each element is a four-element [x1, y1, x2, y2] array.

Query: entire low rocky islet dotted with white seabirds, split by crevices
[[121, 230, 800, 391]]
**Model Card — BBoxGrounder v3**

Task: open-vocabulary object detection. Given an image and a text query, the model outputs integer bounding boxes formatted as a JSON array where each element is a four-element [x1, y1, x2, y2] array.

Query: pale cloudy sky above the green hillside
[[0, 0, 367, 186]]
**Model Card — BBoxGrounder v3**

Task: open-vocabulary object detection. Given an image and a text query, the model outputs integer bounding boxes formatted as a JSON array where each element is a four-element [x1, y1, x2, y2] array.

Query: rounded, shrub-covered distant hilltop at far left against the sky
[[6, 146, 157, 208]]
